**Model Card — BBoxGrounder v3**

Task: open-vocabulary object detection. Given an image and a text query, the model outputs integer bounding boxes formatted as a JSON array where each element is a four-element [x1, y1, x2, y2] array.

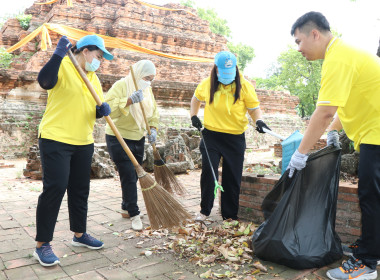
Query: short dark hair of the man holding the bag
[[290, 12, 331, 36]]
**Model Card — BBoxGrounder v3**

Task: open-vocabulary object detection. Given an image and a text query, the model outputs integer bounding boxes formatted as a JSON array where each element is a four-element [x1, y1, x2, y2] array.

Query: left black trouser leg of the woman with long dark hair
[[199, 129, 221, 216]]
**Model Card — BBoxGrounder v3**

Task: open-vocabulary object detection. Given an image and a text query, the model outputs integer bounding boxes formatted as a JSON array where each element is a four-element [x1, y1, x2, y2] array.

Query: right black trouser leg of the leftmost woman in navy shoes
[[67, 144, 94, 233]]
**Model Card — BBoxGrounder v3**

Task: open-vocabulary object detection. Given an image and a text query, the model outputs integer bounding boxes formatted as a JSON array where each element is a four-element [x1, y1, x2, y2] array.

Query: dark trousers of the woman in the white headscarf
[[106, 134, 145, 217]]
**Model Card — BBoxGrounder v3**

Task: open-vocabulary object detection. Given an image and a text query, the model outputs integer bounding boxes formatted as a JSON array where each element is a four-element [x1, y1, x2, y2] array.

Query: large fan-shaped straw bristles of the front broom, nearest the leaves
[[136, 167, 191, 229]]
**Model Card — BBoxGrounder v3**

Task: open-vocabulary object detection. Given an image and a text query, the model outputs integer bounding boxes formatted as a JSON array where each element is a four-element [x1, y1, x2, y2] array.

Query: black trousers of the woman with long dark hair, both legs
[[199, 129, 246, 220]]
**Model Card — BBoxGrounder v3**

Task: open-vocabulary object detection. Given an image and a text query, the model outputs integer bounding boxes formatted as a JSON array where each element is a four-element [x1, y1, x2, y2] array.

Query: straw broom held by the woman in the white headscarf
[[129, 66, 187, 195]]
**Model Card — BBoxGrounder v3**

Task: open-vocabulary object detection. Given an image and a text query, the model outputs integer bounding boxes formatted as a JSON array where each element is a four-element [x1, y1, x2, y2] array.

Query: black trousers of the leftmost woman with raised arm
[[36, 138, 94, 242]]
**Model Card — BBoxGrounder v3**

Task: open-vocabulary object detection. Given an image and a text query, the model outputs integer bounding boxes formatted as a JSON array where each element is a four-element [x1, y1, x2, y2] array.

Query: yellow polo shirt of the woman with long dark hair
[[194, 76, 260, 134]]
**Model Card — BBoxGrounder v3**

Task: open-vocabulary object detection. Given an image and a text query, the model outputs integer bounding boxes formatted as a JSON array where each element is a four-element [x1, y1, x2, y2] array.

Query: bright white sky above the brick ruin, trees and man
[[0, 0, 380, 77]]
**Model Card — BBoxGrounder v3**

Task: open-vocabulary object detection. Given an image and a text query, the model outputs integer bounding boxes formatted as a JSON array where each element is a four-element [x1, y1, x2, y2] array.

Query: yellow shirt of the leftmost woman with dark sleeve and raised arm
[[38, 57, 104, 145]]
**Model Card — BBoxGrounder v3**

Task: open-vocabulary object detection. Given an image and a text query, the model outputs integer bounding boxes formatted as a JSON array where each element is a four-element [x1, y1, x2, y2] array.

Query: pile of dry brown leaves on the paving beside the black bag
[[109, 220, 270, 280]]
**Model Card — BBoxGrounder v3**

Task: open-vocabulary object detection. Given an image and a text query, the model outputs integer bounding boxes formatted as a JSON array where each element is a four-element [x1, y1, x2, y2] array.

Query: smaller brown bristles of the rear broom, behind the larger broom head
[[153, 150, 187, 195]]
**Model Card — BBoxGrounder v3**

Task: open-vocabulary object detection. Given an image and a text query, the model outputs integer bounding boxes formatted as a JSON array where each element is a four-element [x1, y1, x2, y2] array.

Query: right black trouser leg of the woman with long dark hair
[[221, 133, 246, 220]]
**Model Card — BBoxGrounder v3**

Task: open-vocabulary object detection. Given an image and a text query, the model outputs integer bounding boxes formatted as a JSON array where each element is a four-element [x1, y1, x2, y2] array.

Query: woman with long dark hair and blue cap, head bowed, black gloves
[[190, 51, 269, 221]]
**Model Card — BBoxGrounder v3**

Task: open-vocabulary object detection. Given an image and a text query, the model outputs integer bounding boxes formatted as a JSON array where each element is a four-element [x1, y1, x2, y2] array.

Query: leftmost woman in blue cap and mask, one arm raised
[[33, 35, 113, 266]]
